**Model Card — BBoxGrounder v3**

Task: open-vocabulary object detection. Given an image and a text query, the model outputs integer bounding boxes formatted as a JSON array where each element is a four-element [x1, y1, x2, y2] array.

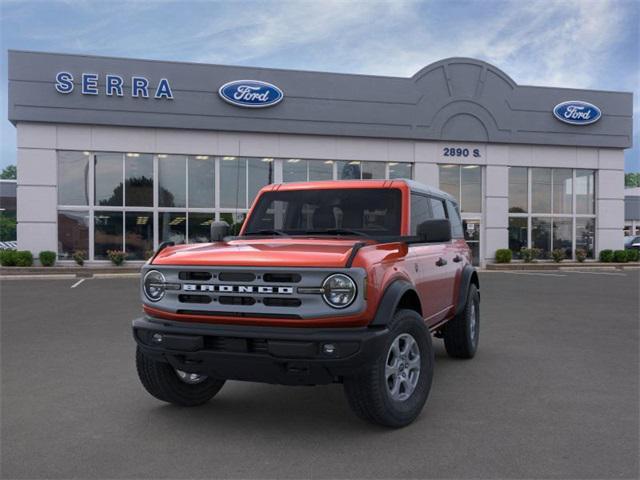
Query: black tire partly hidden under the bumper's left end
[[136, 348, 225, 407]]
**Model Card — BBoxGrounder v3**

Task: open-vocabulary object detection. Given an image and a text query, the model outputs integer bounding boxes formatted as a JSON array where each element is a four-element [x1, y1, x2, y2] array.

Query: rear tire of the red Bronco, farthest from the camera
[[442, 283, 480, 358]]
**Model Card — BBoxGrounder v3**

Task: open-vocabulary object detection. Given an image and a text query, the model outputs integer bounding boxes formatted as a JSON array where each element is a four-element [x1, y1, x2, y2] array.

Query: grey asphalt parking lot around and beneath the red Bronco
[[0, 270, 640, 478]]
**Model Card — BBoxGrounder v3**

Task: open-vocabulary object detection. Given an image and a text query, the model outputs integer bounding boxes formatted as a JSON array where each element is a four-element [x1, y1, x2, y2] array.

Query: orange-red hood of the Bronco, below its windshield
[[152, 238, 374, 268]]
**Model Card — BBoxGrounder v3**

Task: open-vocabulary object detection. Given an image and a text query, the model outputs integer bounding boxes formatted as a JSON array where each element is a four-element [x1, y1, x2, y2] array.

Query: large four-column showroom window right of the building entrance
[[509, 167, 595, 258]]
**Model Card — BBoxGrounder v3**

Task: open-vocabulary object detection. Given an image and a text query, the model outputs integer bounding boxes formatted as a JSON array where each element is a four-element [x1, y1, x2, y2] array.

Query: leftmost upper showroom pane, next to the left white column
[[58, 152, 91, 205]]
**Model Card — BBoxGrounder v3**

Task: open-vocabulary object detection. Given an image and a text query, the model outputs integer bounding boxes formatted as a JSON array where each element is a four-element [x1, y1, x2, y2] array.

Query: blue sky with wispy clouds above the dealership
[[0, 0, 640, 171]]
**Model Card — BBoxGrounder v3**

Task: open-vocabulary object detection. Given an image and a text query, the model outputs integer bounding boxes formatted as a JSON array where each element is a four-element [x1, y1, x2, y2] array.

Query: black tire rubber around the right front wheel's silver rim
[[344, 310, 434, 428]]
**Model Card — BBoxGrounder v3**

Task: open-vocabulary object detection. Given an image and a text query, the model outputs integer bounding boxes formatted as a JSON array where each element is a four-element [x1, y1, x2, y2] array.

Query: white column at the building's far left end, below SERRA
[[16, 123, 58, 256]]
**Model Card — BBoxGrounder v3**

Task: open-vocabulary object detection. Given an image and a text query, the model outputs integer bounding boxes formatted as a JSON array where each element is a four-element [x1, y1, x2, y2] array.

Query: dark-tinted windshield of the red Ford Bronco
[[244, 188, 402, 236]]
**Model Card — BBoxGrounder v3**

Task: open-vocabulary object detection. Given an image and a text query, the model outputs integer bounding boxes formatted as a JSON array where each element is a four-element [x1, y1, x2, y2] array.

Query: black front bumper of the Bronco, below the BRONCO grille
[[133, 317, 389, 385]]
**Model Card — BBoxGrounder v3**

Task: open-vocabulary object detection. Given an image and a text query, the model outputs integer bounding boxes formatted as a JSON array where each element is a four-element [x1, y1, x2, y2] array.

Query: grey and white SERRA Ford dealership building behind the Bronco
[[8, 51, 632, 263]]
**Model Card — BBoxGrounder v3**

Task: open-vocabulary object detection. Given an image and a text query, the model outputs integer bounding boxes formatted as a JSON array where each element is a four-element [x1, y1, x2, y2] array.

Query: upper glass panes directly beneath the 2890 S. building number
[[439, 165, 482, 213]]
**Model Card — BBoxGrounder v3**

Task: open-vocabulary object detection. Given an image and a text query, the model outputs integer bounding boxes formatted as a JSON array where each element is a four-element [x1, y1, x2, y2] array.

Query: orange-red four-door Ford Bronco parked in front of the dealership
[[133, 180, 480, 427]]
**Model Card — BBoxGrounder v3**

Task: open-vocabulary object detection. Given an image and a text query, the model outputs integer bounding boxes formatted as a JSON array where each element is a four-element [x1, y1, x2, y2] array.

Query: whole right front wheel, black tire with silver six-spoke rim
[[344, 310, 434, 428]]
